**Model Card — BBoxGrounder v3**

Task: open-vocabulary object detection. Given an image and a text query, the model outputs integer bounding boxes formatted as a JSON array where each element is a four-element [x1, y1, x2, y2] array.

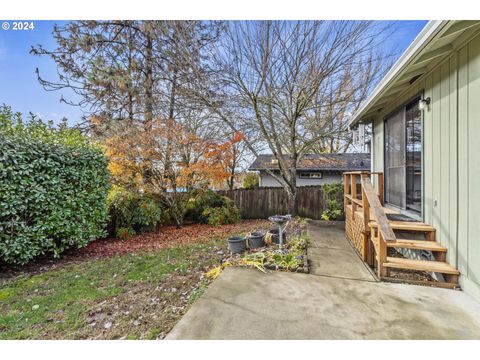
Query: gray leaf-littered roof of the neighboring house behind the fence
[[249, 153, 370, 171]]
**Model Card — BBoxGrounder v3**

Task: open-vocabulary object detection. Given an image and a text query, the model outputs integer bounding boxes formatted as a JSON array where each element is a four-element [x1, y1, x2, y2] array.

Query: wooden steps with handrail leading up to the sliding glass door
[[344, 173, 460, 288]]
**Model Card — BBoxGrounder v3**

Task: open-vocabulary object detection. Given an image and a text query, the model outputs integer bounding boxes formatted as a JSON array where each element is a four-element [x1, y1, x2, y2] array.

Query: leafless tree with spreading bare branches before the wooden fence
[[186, 21, 388, 213]]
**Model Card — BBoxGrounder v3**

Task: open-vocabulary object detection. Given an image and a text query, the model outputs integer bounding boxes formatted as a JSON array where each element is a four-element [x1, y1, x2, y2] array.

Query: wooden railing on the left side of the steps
[[343, 172, 396, 277]]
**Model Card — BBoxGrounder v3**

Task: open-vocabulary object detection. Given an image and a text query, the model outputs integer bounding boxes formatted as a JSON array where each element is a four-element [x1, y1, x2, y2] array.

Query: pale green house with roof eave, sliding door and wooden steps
[[345, 21, 480, 299]]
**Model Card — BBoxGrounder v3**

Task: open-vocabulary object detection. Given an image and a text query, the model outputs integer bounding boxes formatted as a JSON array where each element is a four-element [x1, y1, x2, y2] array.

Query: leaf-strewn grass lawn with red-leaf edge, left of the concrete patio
[[0, 221, 268, 339]]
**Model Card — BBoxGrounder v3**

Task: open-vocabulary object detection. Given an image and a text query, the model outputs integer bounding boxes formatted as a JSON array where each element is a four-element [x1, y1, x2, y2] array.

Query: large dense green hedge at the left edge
[[0, 105, 110, 264]]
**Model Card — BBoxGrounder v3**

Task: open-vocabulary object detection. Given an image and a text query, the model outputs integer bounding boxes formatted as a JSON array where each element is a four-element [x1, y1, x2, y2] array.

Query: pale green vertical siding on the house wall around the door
[[372, 32, 480, 294]]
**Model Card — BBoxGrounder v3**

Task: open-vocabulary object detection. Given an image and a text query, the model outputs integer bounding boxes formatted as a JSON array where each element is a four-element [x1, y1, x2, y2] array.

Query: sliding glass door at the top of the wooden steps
[[385, 98, 422, 215]]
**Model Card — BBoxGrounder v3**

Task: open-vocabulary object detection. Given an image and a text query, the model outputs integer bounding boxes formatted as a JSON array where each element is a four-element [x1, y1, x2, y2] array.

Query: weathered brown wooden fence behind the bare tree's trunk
[[219, 186, 343, 220]]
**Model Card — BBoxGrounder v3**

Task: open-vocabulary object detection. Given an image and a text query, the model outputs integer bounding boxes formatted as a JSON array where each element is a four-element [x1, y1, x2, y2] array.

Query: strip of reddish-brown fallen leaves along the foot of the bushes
[[0, 220, 271, 280]]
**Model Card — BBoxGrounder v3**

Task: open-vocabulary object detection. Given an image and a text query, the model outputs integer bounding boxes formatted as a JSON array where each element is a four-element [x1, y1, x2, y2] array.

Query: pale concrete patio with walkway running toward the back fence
[[167, 222, 480, 339]]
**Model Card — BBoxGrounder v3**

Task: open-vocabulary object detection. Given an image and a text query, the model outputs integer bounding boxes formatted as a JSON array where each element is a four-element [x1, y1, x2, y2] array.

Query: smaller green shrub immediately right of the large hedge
[[108, 186, 162, 239]]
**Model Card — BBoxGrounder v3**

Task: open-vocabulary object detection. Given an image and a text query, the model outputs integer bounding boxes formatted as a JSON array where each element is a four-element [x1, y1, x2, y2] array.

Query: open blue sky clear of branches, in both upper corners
[[0, 20, 427, 124]]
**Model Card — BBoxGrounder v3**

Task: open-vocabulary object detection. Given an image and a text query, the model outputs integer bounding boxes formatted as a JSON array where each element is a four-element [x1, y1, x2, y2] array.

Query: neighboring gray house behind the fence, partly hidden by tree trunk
[[249, 153, 370, 187]]
